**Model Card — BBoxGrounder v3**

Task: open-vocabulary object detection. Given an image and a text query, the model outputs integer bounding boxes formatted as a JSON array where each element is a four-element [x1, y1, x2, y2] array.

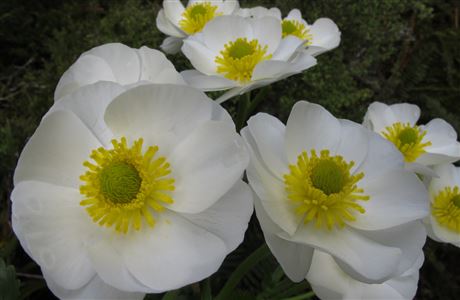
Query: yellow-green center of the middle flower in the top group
[[214, 38, 272, 83]]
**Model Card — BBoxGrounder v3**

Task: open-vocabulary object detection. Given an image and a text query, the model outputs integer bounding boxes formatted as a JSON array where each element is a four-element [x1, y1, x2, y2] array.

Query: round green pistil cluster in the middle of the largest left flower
[[99, 162, 142, 204]]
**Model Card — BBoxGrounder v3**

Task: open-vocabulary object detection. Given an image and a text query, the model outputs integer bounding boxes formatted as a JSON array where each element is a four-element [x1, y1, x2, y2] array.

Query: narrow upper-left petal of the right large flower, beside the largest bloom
[[248, 113, 289, 180]]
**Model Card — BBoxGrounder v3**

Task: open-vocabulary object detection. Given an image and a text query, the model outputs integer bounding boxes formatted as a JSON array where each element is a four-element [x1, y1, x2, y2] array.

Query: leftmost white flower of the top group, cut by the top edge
[[156, 0, 240, 54]]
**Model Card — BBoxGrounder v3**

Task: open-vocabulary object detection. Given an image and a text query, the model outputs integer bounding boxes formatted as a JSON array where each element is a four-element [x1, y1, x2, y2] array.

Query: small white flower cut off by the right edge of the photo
[[424, 164, 460, 247]]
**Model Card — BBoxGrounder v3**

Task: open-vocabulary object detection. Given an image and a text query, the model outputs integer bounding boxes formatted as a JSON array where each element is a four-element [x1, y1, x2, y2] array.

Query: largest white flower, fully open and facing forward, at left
[[11, 82, 252, 299]]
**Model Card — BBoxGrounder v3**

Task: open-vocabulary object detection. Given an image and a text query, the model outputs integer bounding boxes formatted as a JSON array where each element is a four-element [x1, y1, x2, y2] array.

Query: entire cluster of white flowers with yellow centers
[[11, 0, 460, 299]]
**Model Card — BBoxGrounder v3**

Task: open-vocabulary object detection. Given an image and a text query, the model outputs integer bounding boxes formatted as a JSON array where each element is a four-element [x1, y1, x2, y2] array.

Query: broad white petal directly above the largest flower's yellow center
[[104, 84, 226, 155]]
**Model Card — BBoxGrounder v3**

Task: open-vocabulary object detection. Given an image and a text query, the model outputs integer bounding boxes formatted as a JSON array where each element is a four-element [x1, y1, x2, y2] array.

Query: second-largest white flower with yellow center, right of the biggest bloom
[[242, 101, 428, 283]]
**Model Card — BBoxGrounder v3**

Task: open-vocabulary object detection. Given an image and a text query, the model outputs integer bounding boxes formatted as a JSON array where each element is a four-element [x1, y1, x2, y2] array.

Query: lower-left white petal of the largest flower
[[11, 181, 97, 289]]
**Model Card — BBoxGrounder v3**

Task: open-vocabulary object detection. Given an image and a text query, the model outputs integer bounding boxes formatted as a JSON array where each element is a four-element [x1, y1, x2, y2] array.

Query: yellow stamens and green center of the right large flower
[[284, 150, 369, 230]]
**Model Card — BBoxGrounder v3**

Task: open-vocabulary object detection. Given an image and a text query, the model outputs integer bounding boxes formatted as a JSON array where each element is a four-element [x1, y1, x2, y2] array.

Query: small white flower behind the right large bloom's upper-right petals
[[363, 102, 460, 175]]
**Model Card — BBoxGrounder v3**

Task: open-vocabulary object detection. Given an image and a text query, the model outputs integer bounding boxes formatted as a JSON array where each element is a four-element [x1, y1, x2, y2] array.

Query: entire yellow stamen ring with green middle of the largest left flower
[[80, 137, 174, 233]]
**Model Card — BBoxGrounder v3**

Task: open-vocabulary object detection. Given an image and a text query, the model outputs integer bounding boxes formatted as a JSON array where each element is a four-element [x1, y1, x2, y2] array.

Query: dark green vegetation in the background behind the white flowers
[[0, 0, 460, 299]]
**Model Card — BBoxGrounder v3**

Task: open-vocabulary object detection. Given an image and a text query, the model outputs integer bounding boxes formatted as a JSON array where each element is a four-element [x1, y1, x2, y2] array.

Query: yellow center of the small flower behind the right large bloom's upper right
[[381, 122, 431, 162]]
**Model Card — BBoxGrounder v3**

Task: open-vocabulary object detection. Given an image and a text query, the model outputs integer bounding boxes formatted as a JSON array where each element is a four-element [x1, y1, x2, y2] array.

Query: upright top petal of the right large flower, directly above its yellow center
[[286, 101, 342, 163]]
